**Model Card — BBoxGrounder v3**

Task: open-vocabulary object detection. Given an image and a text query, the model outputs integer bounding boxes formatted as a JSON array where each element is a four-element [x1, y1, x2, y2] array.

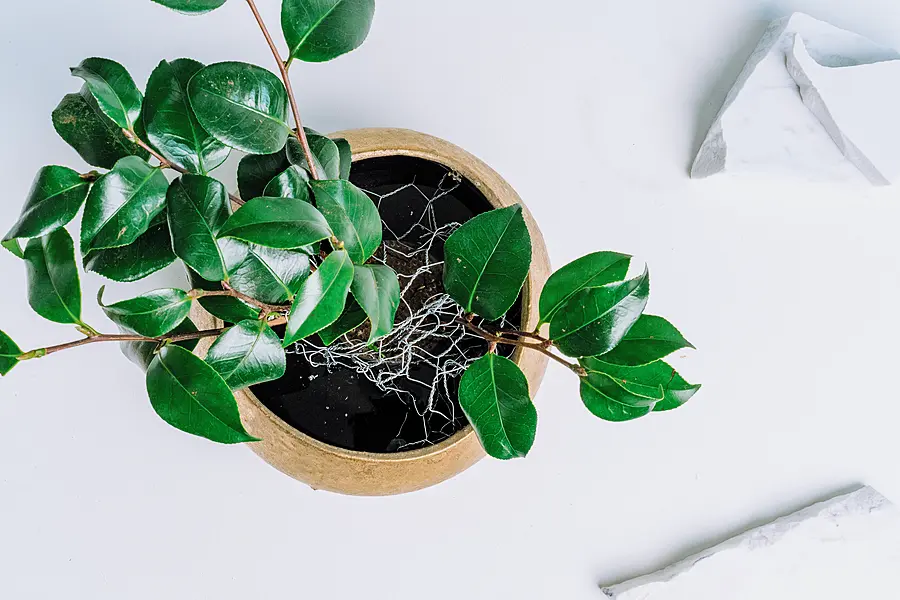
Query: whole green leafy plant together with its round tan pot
[[0, 0, 699, 494]]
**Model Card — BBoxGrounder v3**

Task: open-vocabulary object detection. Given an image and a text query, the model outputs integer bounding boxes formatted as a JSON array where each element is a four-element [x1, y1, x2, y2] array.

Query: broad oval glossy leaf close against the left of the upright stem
[[188, 62, 291, 154]]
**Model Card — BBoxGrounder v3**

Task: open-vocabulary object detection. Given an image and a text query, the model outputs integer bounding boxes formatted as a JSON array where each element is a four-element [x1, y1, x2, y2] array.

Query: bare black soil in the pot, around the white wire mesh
[[252, 156, 521, 452]]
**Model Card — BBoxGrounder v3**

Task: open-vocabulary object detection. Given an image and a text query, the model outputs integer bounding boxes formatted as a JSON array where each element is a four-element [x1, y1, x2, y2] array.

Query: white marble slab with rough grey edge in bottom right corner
[[603, 487, 900, 600]]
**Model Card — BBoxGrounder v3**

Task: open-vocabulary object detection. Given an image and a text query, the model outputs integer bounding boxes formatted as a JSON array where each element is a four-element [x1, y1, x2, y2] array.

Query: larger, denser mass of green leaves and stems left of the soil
[[0, 0, 386, 443]]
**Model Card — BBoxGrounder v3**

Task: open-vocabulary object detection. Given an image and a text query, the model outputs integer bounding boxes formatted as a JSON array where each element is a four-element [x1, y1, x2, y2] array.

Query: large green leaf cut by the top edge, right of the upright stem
[[281, 0, 375, 62]]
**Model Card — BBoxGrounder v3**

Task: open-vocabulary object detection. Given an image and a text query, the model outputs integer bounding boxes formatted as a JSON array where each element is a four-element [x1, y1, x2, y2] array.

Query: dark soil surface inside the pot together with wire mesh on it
[[252, 156, 521, 453]]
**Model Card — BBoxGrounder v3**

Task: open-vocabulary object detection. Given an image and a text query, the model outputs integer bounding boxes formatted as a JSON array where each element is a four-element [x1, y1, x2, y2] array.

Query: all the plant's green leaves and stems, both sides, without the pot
[[0, 0, 699, 459]]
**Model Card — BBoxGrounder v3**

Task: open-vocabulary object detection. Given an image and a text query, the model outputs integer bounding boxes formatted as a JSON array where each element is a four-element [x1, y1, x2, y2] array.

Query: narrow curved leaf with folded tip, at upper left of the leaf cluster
[[71, 58, 143, 130]]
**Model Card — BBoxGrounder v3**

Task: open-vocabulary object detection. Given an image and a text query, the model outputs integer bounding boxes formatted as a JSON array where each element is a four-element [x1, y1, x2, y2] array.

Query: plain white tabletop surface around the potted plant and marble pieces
[[0, 0, 900, 600]]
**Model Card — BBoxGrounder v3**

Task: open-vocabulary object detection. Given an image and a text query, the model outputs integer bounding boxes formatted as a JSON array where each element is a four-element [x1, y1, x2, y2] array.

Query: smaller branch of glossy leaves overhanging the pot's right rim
[[444, 206, 700, 459]]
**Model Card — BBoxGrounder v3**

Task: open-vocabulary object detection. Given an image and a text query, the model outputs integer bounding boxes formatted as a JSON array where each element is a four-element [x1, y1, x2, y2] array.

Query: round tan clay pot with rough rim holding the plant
[[192, 129, 550, 496]]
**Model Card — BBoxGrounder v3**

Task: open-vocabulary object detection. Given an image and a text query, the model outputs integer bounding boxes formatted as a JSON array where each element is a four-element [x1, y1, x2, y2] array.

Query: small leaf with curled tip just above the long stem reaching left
[[97, 287, 191, 337]]
